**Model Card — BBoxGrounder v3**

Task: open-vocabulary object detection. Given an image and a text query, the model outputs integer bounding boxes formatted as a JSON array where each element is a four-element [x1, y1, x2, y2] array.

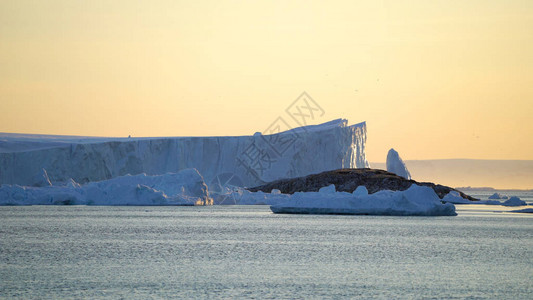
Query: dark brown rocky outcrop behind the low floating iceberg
[[248, 168, 479, 201]]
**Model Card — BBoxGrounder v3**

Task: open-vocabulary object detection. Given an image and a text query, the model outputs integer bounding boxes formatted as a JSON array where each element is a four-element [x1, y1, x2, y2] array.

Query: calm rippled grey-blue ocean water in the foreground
[[0, 206, 533, 299]]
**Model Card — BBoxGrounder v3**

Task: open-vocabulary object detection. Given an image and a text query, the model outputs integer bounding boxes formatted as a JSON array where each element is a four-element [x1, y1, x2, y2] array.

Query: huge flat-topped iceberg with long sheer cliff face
[[0, 119, 368, 190]]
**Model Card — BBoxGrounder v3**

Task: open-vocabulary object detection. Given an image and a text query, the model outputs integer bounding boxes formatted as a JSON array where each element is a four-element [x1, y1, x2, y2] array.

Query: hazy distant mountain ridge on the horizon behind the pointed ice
[[370, 159, 533, 190]]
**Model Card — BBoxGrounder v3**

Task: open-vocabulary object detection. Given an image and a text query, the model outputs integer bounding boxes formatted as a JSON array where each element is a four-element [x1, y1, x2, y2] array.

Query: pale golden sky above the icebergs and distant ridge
[[0, 0, 533, 161]]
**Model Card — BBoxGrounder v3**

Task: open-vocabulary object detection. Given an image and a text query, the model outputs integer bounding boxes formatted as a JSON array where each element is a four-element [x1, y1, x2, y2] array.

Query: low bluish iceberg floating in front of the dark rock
[[270, 184, 457, 216]]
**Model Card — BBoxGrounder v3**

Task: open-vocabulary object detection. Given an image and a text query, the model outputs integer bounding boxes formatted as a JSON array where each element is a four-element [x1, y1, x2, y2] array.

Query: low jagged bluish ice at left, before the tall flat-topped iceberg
[[0, 169, 212, 205]]
